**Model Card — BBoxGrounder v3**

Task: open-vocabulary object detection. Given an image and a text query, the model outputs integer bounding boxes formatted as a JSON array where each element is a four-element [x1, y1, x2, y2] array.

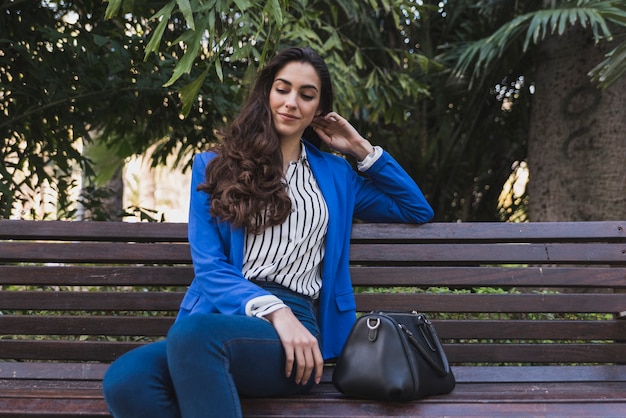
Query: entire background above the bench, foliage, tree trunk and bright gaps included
[[0, 0, 626, 222]]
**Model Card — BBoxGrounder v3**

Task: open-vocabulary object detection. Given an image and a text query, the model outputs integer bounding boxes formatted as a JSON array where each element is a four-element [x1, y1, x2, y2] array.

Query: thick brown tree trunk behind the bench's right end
[[528, 27, 626, 222]]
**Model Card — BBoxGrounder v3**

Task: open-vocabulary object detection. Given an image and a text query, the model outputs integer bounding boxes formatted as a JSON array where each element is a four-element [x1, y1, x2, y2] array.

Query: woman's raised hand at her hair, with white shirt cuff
[[311, 112, 374, 161]]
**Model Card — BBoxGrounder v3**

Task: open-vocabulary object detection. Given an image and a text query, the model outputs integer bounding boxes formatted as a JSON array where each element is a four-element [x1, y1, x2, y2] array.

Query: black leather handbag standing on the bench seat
[[333, 312, 456, 401]]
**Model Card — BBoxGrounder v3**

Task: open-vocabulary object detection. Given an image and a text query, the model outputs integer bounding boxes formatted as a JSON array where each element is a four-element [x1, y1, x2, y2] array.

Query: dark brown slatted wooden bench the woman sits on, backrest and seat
[[0, 220, 626, 417]]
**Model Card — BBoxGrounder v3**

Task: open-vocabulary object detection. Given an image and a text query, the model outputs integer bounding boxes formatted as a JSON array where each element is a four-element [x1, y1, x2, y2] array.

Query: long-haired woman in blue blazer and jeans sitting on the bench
[[104, 48, 433, 418]]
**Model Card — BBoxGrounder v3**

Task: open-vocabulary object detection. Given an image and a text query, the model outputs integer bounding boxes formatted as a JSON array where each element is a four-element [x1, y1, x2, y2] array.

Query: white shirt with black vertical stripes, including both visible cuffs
[[243, 146, 382, 317]]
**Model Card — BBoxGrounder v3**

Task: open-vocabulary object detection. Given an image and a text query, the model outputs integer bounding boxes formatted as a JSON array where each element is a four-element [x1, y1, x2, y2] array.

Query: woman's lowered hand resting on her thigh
[[265, 307, 324, 385]]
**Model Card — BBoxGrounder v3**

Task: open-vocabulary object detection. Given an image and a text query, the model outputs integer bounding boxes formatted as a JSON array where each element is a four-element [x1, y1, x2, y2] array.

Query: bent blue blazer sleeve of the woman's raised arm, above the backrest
[[354, 151, 434, 223]]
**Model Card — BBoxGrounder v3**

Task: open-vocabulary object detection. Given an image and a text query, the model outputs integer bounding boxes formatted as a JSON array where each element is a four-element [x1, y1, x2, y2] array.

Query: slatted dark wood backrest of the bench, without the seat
[[0, 220, 626, 364]]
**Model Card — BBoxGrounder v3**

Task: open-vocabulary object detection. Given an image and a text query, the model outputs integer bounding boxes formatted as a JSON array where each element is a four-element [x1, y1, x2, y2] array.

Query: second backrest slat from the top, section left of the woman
[[0, 242, 191, 264]]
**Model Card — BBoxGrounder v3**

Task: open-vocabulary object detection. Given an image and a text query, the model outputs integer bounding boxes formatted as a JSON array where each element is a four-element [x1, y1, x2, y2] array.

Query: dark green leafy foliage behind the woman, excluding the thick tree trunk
[[0, 0, 626, 221]]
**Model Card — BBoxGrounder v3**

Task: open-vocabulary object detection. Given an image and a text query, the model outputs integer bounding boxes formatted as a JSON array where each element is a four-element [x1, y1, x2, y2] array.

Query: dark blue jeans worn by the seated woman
[[103, 283, 320, 418]]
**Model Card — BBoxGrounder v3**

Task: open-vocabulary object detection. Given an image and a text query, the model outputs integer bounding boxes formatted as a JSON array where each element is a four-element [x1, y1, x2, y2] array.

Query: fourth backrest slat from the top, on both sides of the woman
[[0, 291, 626, 314]]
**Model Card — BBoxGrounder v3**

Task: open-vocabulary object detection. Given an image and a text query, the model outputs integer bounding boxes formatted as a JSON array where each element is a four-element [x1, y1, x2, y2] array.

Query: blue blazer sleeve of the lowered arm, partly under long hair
[[181, 153, 270, 315]]
